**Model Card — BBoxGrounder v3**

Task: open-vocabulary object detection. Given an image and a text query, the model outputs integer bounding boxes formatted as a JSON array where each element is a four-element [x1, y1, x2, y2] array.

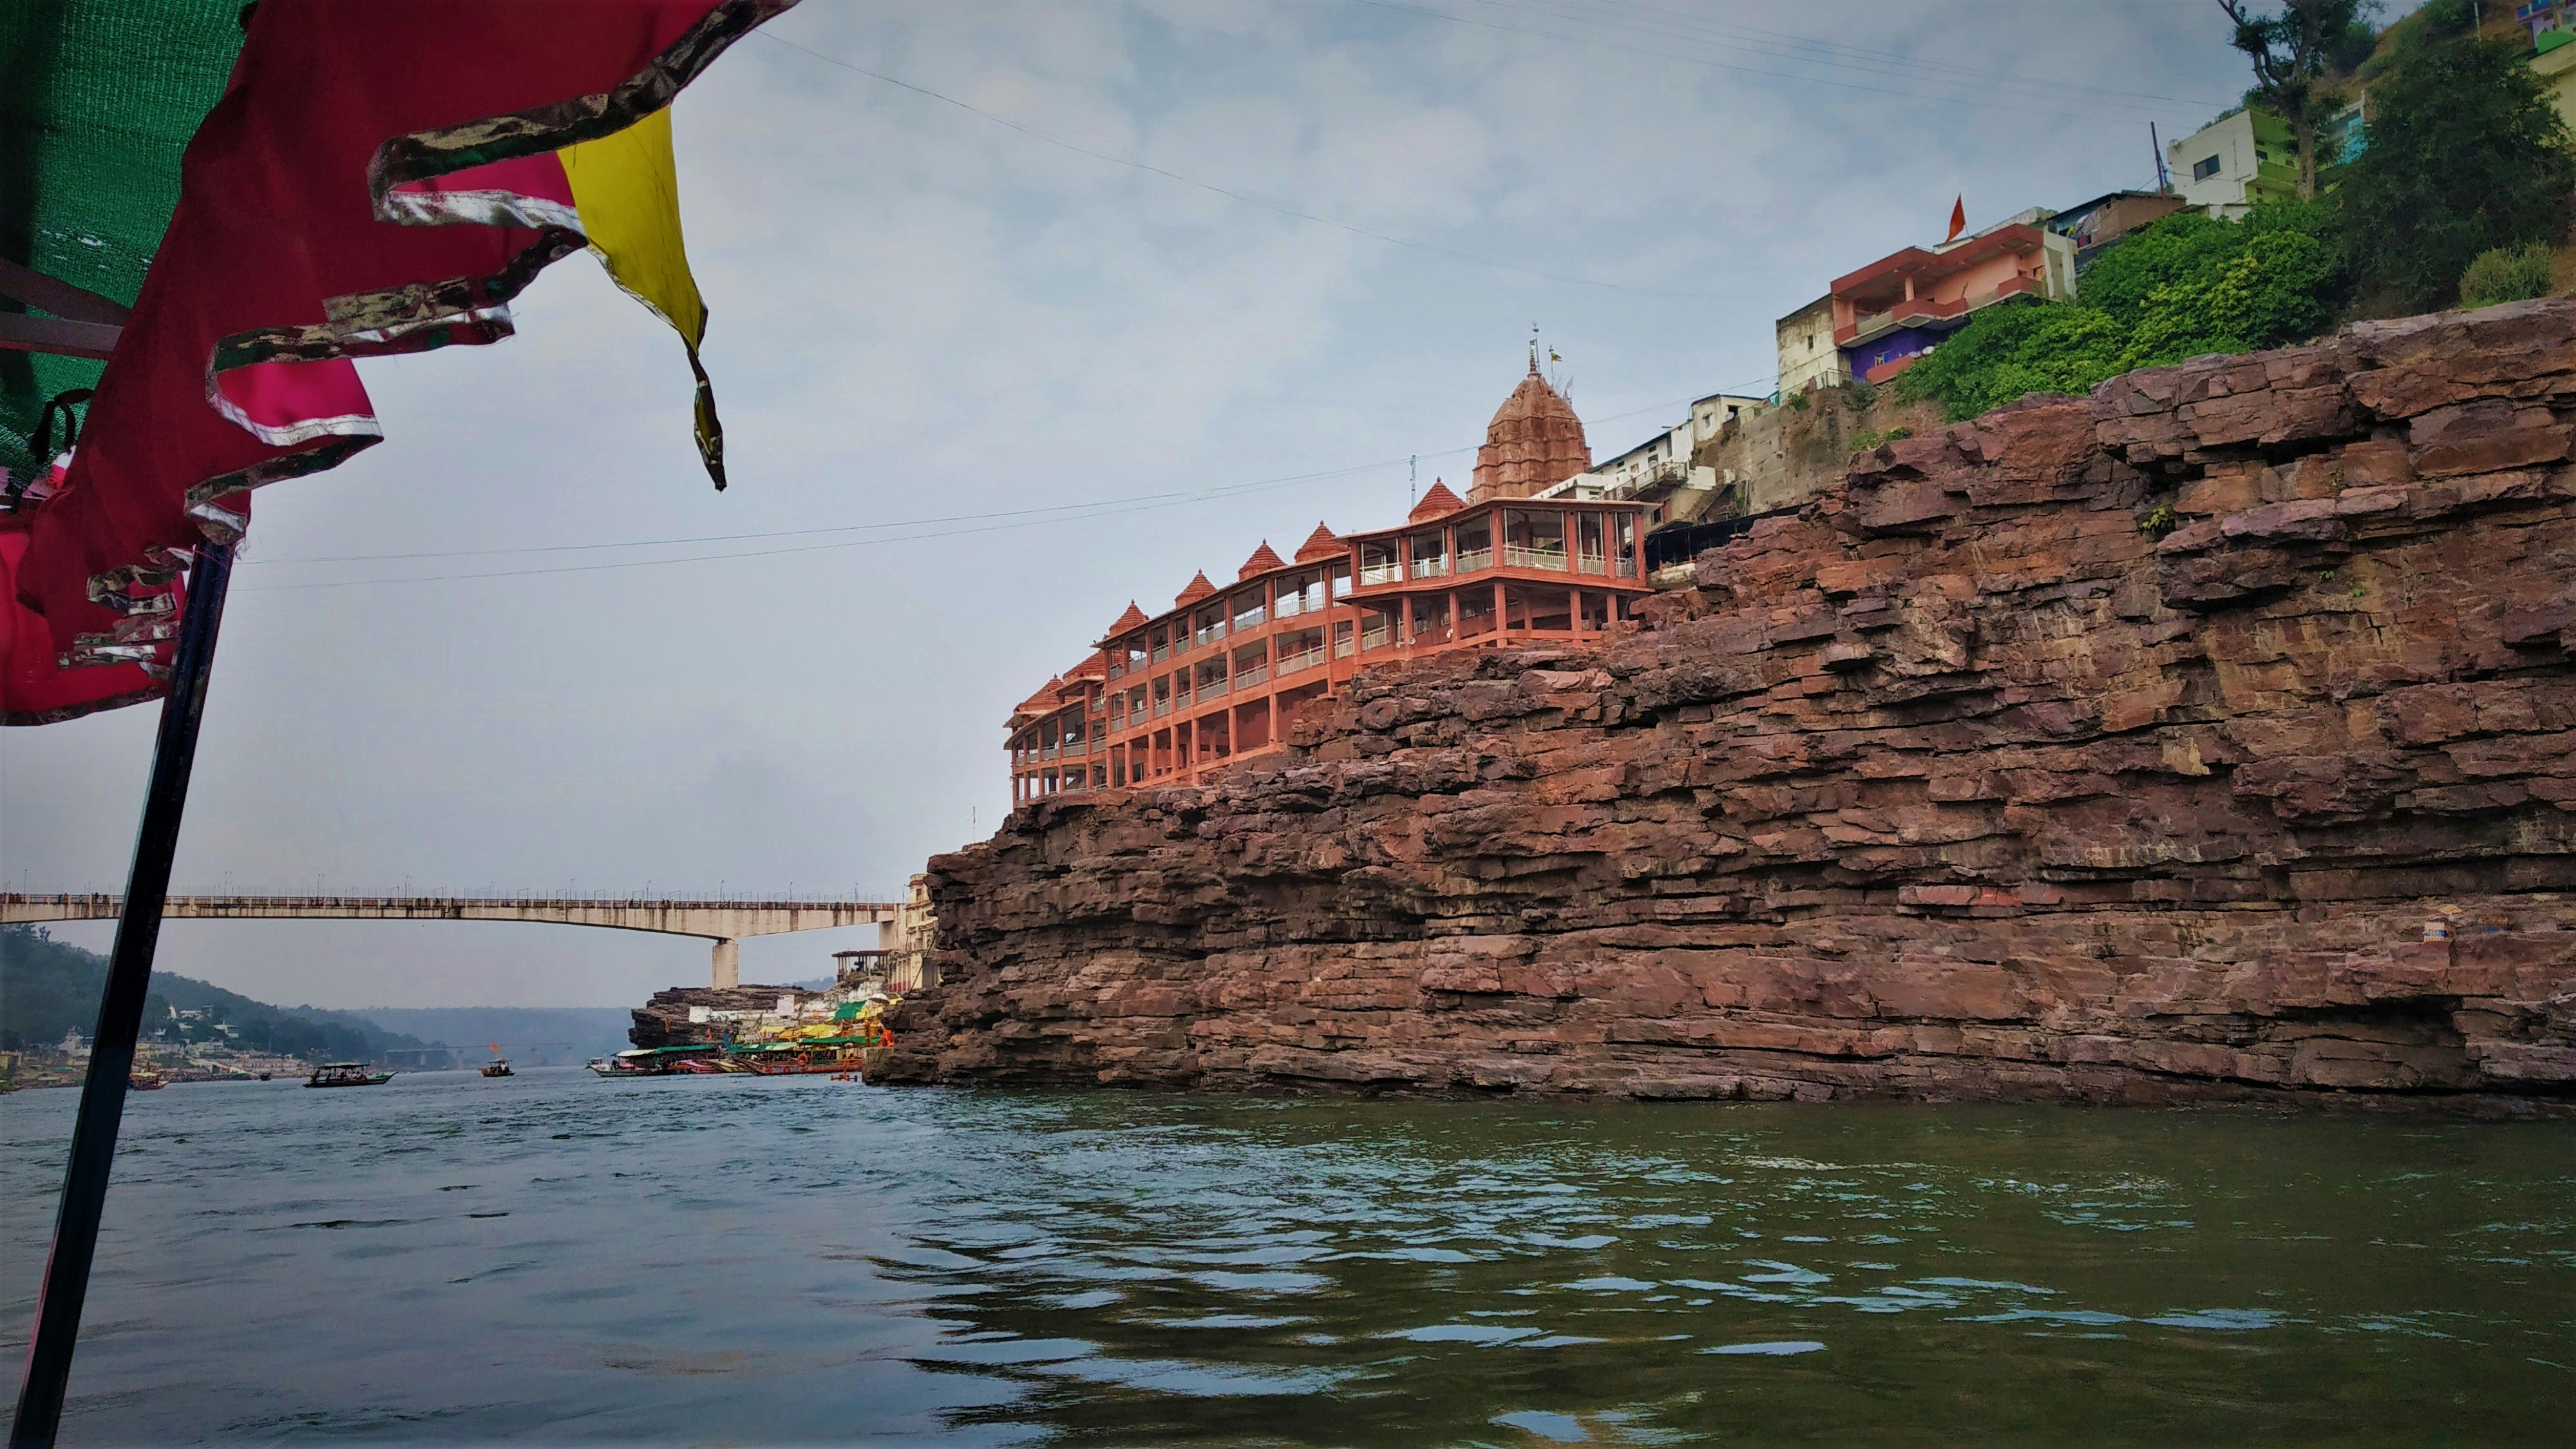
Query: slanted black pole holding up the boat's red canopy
[[8, 544, 232, 1449]]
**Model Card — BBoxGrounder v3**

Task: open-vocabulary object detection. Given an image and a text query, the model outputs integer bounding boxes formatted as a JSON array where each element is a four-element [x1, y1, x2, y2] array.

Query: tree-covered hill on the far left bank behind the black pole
[[0, 925, 433, 1062]]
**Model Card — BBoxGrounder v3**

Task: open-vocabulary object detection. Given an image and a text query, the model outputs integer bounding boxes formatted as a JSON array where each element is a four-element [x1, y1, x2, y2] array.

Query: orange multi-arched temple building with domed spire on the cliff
[[1010, 353, 1651, 804]]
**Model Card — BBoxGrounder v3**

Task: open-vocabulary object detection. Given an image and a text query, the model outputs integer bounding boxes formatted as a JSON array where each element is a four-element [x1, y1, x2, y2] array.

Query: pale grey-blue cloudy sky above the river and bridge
[[0, 0, 2244, 1005]]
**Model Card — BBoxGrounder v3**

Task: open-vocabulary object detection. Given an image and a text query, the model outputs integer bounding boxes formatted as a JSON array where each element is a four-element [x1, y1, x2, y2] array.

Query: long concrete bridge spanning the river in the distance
[[0, 892, 904, 985]]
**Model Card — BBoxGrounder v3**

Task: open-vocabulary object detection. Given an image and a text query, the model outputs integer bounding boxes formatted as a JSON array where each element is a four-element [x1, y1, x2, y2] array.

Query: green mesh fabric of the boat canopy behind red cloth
[[0, 0, 242, 477]]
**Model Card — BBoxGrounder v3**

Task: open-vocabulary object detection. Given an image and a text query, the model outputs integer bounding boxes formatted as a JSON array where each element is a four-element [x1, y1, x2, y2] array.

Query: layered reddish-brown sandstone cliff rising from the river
[[873, 301, 2576, 1109]]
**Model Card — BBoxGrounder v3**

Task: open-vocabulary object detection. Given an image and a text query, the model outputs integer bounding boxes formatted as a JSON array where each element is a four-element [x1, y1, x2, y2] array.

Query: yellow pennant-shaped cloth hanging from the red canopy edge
[[554, 108, 724, 490]]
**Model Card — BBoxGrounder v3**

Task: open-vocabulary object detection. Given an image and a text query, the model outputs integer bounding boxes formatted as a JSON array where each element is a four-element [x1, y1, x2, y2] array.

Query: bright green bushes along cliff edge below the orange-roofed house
[[1896, 201, 2344, 423]]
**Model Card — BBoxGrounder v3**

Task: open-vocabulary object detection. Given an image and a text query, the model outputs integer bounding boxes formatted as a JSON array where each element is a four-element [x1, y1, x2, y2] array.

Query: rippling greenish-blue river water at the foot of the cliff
[[0, 1070, 2576, 1446]]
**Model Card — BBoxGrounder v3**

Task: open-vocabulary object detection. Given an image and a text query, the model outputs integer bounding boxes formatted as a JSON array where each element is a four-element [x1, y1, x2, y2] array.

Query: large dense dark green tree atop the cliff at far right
[[2342, 36, 2576, 312]]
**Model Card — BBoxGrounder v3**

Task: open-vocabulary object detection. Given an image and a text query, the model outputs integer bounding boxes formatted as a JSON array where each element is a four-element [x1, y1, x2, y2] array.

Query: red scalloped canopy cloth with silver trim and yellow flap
[[0, 0, 796, 724]]
